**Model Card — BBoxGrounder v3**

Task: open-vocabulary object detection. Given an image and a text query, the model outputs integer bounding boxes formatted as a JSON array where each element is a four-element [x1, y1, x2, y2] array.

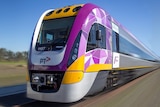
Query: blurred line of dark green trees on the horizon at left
[[0, 48, 28, 61]]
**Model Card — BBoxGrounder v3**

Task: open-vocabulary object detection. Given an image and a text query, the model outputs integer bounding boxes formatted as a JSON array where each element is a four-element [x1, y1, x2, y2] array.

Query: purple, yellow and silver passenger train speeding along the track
[[27, 3, 160, 103]]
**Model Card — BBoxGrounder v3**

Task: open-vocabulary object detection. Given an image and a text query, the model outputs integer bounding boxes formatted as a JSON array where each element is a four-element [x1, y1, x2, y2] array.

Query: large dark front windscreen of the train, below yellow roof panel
[[36, 17, 75, 51]]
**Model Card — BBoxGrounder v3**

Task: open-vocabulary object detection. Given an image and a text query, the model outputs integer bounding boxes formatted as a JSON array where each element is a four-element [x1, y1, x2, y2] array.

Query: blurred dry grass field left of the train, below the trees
[[0, 61, 27, 87]]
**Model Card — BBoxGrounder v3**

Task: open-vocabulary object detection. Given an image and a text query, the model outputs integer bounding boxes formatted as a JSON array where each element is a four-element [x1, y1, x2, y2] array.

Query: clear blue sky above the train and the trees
[[0, 0, 160, 56]]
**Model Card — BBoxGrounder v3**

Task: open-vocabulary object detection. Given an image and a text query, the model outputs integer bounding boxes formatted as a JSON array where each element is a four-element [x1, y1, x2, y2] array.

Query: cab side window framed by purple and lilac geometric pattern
[[86, 23, 106, 51]]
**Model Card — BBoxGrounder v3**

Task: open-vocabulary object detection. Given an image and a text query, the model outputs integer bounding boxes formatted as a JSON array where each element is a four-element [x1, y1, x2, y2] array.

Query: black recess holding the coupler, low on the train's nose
[[30, 71, 64, 93]]
